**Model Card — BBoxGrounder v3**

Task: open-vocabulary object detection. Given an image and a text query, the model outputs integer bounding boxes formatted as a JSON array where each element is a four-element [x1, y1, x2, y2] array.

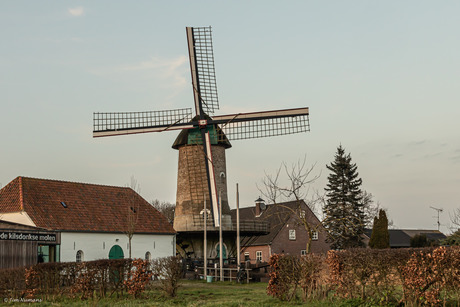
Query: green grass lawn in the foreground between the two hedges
[[0, 281, 363, 307]]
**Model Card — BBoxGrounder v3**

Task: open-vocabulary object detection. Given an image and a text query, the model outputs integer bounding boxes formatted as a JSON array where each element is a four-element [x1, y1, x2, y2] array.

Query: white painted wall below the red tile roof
[[61, 232, 176, 262]]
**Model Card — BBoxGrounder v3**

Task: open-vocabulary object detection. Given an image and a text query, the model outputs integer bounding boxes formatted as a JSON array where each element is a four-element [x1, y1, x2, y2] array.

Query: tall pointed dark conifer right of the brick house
[[323, 145, 364, 249]]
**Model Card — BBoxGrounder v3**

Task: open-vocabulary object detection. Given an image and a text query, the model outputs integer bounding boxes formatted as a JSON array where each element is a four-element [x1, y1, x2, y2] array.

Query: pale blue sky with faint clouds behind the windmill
[[0, 1, 460, 232]]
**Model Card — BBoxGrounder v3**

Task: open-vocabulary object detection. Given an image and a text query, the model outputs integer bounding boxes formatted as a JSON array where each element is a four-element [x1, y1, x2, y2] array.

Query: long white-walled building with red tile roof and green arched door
[[0, 177, 176, 264]]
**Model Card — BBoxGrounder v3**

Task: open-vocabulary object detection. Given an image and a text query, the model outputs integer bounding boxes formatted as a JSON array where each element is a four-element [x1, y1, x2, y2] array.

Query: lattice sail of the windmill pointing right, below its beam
[[220, 114, 310, 141]]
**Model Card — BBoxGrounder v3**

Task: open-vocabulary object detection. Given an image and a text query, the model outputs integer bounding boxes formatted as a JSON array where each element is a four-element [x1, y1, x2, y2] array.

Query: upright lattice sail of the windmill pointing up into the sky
[[193, 27, 219, 114]]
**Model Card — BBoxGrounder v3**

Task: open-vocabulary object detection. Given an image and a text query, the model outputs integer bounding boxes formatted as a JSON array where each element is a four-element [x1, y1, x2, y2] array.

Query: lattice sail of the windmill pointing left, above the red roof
[[93, 108, 193, 136]]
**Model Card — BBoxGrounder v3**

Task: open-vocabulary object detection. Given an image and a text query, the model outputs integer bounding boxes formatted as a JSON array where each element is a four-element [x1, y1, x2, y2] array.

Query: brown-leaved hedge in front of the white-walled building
[[0, 257, 181, 299]]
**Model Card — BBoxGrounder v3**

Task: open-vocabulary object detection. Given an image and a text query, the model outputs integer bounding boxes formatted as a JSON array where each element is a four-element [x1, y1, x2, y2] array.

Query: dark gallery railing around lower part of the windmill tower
[[176, 215, 270, 234]]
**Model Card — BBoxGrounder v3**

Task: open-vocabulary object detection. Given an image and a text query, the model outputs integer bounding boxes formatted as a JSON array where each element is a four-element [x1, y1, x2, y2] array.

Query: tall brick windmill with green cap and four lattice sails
[[93, 27, 310, 258]]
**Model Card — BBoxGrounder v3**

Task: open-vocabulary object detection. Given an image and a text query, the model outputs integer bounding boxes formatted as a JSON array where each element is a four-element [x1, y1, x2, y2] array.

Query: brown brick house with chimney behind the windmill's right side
[[232, 199, 330, 263]]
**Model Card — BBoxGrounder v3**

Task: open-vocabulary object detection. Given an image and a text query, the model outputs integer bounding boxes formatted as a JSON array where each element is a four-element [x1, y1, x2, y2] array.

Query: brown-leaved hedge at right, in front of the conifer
[[267, 247, 460, 305]]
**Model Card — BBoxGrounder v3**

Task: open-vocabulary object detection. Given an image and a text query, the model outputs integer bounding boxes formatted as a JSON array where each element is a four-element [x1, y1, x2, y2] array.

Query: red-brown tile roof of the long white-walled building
[[0, 177, 175, 234]]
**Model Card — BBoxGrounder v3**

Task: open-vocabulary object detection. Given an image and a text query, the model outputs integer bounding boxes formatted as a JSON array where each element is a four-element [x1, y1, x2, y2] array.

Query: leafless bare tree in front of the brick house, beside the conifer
[[259, 157, 324, 253]]
